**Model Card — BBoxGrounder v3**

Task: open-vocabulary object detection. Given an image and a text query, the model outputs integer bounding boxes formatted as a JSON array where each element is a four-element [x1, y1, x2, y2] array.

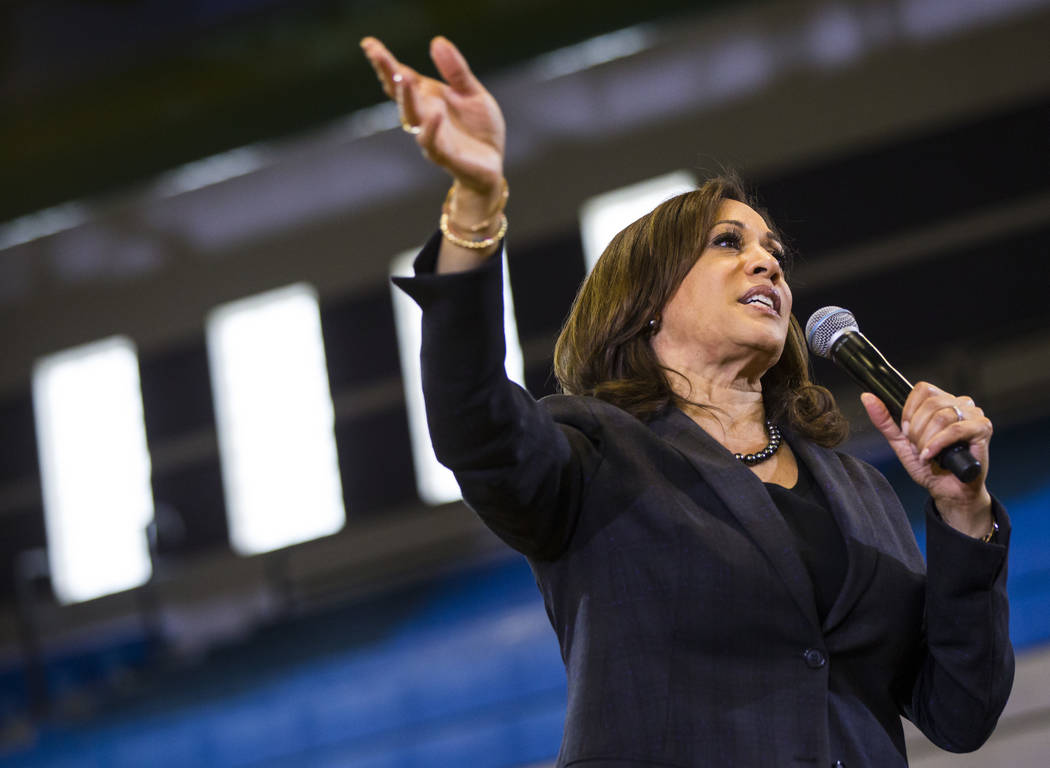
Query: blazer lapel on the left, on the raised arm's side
[[650, 409, 820, 627]]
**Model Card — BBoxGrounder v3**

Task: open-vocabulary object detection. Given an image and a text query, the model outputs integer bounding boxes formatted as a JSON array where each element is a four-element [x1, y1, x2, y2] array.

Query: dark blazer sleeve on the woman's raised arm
[[394, 233, 603, 560]]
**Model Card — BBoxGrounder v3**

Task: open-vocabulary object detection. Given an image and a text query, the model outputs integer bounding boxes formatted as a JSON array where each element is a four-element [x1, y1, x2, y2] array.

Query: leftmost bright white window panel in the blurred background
[[33, 336, 153, 604]]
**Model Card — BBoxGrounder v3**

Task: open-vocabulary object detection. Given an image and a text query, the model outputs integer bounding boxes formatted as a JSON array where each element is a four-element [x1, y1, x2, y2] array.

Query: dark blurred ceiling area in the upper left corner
[[0, 0, 722, 222]]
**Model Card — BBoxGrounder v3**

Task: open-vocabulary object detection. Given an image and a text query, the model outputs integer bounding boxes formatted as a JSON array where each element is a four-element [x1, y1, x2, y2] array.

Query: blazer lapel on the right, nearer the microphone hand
[[784, 431, 879, 632]]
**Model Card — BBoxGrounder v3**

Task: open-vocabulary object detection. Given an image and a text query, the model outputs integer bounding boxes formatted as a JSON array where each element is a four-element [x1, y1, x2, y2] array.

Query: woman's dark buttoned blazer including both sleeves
[[397, 238, 1013, 768]]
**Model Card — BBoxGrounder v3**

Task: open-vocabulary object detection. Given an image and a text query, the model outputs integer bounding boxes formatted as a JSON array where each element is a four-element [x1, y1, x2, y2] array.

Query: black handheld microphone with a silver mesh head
[[805, 307, 981, 482]]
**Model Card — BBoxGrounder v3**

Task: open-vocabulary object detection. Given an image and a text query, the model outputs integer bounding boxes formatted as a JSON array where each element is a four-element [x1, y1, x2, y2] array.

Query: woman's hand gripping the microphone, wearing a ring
[[861, 381, 992, 537]]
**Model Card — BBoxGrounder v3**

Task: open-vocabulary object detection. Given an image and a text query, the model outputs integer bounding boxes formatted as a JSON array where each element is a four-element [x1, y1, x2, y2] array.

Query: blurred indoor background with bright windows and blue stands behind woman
[[0, 0, 1050, 768]]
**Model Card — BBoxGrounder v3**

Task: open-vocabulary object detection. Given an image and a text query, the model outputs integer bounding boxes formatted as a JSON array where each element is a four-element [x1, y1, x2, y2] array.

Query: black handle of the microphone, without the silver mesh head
[[832, 331, 981, 482]]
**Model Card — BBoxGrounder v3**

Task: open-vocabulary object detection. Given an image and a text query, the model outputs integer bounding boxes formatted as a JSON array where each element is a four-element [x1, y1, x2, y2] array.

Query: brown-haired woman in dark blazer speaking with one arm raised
[[362, 38, 1013, 768]]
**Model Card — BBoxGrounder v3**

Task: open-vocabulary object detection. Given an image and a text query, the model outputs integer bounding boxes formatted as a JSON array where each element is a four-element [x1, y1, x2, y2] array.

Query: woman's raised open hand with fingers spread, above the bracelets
[[361, 37, 506, 196]]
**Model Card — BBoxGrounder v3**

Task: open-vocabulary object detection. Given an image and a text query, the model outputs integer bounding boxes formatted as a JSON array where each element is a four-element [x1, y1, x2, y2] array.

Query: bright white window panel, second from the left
[[207, 284, 347, 555]]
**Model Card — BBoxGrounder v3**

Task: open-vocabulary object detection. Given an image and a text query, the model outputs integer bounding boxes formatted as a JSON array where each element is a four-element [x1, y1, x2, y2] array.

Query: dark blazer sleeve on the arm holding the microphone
[[903, 500, 1014, 752]]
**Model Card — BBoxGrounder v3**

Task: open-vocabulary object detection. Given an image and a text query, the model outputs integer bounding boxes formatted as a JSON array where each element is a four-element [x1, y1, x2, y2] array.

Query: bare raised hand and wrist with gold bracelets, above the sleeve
[[361, 37, 507, 273]]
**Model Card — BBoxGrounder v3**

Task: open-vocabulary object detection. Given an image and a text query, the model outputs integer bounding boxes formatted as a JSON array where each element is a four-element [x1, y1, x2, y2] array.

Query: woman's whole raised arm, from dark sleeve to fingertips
[[361, 38, 602, 559]]
